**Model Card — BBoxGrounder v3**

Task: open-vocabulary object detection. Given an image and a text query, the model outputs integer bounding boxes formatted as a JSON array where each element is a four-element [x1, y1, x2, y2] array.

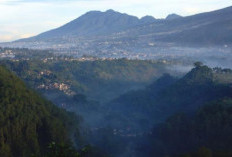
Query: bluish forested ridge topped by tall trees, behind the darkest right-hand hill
[[110, 64, 232, 124]]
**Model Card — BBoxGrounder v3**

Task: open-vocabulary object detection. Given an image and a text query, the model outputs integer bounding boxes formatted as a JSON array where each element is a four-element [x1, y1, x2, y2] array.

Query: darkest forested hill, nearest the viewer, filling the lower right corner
[[151, 99, 232, 157]]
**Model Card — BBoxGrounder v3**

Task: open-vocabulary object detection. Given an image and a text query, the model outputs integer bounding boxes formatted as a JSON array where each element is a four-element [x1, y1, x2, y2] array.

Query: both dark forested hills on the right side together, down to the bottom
[[106, 62, 232, 157]]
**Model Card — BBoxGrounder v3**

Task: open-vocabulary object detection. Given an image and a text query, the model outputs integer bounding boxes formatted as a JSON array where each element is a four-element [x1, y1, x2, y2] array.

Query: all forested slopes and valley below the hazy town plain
[[0, 51, 232, 157]]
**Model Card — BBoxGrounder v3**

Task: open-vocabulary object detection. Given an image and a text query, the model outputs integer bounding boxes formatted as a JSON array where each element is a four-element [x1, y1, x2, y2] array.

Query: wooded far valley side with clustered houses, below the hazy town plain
[[1, 57, 168, 102]]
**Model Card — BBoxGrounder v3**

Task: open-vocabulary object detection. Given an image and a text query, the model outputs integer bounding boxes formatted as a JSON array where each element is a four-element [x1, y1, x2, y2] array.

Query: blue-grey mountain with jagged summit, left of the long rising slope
[[35, 10, 156, 39]]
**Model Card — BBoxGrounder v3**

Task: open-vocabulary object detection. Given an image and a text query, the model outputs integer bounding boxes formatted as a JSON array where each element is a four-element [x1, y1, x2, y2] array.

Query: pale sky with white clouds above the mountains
[[0, 0, 232, 42]]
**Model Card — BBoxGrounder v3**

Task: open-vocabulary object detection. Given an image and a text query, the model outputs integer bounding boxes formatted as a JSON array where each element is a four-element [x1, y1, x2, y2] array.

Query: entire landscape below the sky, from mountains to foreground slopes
[[0, 3, 232, 157]]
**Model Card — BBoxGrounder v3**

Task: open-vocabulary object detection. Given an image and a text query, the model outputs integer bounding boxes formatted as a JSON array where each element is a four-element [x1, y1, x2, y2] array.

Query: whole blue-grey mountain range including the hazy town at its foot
[[0, 7, 232, 57]]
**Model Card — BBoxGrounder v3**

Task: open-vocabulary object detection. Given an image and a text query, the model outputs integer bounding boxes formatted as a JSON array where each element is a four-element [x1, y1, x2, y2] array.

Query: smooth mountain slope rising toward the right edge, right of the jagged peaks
[[116, 7, 232, 45]]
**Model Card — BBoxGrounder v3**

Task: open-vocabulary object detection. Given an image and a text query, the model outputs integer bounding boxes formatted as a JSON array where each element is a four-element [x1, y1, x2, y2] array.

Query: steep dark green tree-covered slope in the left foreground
[[0, 67, 79, 157]]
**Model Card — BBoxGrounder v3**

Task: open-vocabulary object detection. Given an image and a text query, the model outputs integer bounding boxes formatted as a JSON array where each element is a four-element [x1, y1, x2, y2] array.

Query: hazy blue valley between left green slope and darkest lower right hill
[[0, 48, 232, 156]]
